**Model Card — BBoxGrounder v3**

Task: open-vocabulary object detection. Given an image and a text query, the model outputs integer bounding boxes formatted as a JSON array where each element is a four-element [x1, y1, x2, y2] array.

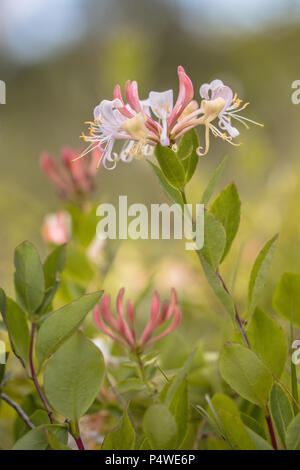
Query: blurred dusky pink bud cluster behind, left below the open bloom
[[40, 147, 99, 199]]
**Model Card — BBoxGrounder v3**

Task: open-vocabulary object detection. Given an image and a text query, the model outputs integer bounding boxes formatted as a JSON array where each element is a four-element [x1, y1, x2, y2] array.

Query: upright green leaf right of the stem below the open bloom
[[210, 183, 241, 261]]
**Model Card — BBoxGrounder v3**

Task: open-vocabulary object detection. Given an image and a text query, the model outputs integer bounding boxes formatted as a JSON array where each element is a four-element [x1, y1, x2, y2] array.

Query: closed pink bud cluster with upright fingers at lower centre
[[94, 289, 181, 353]]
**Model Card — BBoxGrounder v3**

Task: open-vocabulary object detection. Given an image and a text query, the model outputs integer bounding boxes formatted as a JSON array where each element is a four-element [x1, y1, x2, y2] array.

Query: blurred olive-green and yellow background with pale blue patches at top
[[0, 0, 300, 448]]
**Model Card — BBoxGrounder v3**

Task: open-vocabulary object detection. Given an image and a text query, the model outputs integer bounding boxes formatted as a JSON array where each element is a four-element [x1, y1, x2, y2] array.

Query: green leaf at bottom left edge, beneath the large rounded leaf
[[12, 424, 68, 450]]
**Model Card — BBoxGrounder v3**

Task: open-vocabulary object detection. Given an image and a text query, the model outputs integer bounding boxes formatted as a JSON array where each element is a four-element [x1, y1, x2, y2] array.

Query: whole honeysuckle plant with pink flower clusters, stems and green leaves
[[0, 67, 300, 451]]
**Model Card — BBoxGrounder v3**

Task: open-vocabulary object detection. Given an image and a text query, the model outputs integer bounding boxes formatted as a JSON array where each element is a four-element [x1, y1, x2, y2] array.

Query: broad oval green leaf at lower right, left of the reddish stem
[[220, 343, 273, 407]]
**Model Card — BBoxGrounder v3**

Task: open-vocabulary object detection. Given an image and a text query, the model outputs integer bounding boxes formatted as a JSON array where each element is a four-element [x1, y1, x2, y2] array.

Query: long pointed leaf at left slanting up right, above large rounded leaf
[[36, 292, 102, 365]]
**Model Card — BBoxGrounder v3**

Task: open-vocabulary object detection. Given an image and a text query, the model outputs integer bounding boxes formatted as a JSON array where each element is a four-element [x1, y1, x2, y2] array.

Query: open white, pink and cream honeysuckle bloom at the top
[[81, 66, 260, 170]]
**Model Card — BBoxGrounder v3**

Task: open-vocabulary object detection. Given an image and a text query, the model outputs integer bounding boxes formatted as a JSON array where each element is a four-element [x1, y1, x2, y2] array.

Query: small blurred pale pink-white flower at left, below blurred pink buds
[[42, 211, 71, 245]]
